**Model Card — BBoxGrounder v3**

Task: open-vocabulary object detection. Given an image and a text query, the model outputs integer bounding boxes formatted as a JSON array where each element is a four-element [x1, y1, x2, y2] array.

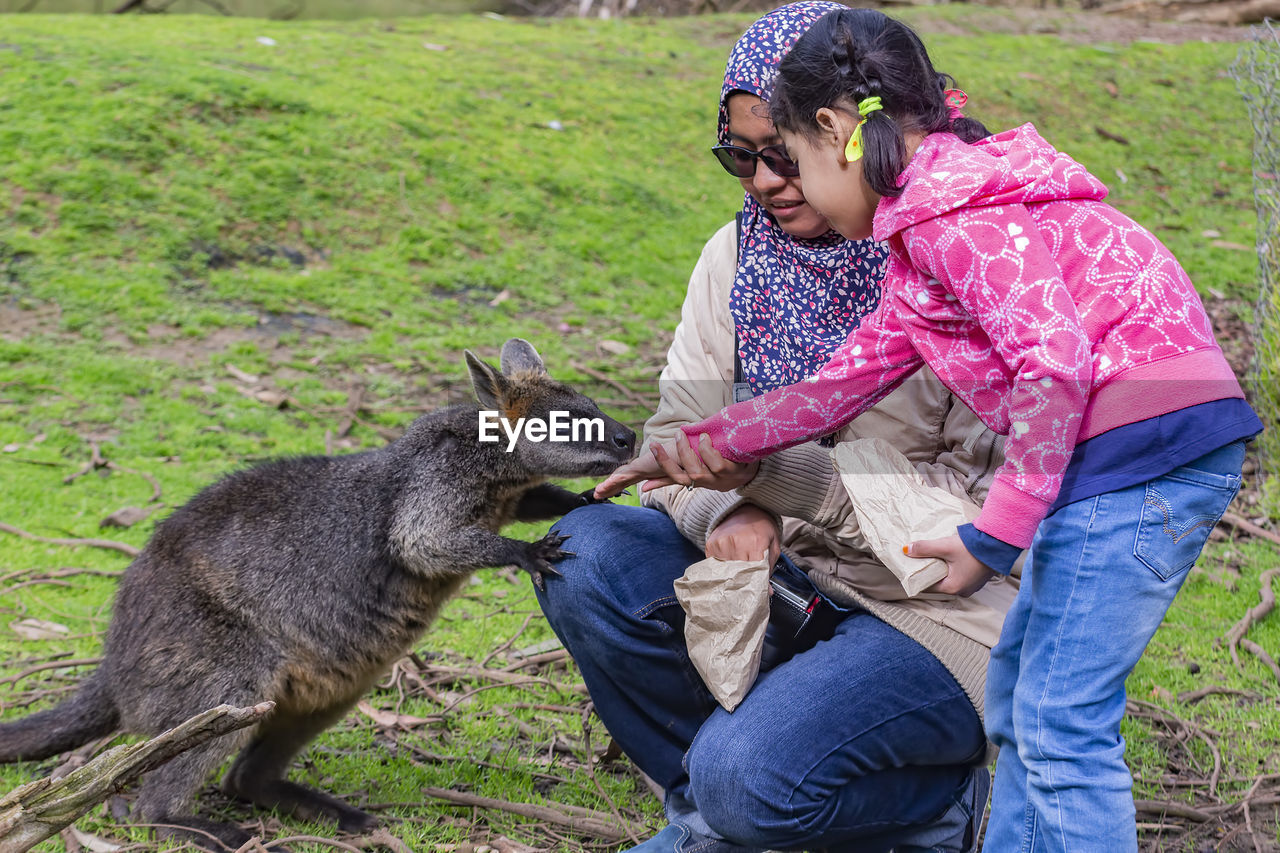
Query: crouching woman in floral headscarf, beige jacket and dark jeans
[[539, 3, 1016, 853]]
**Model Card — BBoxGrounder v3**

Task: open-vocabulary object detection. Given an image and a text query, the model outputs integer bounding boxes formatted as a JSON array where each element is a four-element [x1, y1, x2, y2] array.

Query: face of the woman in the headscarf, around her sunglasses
[[728, 92, 831, 240]]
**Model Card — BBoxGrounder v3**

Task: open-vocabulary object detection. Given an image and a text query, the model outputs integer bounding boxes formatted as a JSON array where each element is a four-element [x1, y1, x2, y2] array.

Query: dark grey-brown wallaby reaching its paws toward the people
[[0, 338, 635, 849]]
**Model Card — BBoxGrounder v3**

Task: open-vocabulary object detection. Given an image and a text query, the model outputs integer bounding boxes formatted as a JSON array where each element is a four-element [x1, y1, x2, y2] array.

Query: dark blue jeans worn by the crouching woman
[[539, 505, 986, 853]]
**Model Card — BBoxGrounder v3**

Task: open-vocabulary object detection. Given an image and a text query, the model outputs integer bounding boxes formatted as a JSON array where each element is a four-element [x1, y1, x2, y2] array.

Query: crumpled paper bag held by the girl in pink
[[832, 438, 979, 598]]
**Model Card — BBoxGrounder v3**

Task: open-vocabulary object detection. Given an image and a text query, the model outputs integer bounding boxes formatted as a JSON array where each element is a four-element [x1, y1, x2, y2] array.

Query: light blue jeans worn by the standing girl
[[984, 442, 1244, 853]]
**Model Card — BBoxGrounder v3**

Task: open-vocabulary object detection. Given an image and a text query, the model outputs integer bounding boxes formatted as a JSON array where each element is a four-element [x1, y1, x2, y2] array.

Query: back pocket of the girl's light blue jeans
[[1133, 467, 1240, 580]]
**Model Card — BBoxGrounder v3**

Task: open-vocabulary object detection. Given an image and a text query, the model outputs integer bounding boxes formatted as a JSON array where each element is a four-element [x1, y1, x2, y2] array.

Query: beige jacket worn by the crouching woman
[[643, 223, 1019, 715]]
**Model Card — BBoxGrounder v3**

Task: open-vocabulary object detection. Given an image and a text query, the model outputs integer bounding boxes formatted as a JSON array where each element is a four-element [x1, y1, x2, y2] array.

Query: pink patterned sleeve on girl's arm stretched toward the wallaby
[[682, 293, 923, 462]]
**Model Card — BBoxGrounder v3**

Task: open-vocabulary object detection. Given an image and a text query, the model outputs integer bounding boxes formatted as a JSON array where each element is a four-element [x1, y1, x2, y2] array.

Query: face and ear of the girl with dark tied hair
[[781, 109, 879, 240]]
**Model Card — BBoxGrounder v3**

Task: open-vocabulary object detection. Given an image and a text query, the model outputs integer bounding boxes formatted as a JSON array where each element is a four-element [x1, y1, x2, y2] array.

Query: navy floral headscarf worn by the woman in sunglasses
[[717, 1, 888, 394]]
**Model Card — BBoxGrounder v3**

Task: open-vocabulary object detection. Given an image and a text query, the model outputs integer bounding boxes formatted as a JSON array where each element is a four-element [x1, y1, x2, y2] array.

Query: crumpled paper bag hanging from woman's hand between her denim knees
[[676, 557, 772, 711]]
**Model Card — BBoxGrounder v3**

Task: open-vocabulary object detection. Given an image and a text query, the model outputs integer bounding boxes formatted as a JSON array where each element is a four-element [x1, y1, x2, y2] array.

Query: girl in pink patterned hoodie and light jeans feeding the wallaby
[[596, 9, 1262, 853]]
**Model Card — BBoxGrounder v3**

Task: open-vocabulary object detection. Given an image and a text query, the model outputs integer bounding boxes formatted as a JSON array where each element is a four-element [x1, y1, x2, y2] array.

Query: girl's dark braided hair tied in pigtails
[[769, 9, 989, 197]]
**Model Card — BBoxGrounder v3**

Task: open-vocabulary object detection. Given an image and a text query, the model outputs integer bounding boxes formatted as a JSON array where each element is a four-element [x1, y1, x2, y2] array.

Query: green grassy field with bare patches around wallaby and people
[[0, 8, 1280, 850]]
